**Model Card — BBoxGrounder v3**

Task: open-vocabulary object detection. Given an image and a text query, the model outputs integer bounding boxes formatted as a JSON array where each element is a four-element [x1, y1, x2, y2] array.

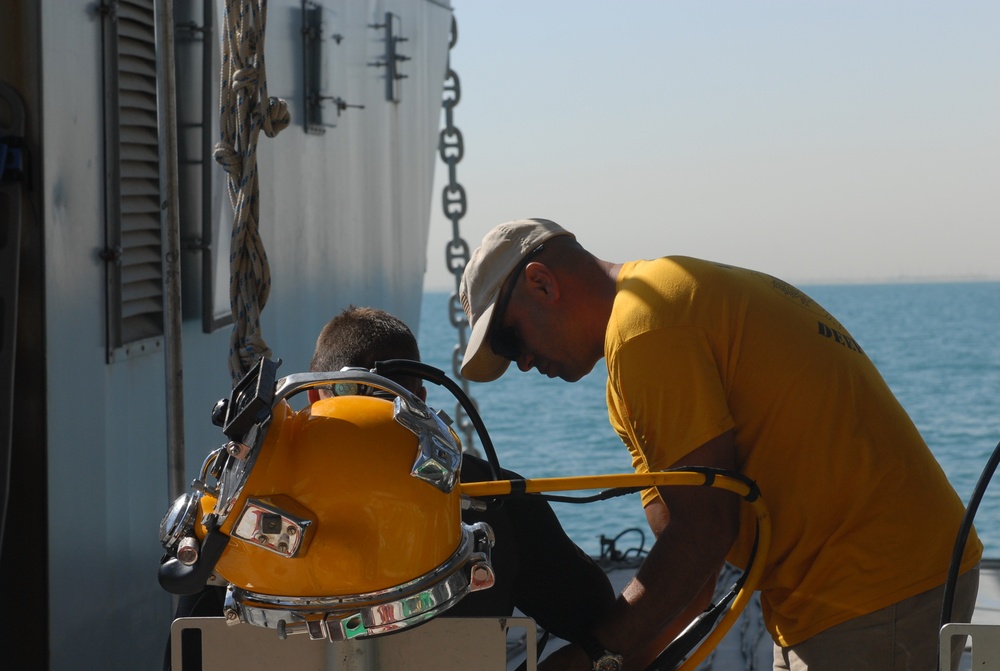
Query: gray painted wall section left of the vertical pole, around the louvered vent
[[42, 2, 169, 669]]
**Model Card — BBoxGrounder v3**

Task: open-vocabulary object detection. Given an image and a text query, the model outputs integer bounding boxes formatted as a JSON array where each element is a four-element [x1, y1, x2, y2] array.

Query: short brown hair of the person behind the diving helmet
[[309, 305, 423, 393]]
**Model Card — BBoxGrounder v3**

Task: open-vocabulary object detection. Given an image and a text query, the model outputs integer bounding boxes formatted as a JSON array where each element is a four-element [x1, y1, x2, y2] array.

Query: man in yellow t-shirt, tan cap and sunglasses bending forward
[[460, 219, 982, 671]]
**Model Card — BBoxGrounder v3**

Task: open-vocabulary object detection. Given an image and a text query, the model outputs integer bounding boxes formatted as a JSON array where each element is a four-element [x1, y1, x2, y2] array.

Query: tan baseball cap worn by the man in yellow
[[458, 219, 574, 382]]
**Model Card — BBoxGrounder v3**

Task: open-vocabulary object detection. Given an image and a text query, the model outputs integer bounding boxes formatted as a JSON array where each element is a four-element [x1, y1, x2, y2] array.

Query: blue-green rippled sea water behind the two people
[[419, 282, 1000, 557]]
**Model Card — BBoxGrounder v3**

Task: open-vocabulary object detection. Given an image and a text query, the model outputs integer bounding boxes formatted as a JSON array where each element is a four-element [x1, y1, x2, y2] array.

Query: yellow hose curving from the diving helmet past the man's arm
[[459, 467, 771, 671]]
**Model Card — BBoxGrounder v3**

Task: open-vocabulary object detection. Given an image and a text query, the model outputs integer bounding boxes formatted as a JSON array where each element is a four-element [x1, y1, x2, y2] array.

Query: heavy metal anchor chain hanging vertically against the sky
[[438, 16, 478, 455]]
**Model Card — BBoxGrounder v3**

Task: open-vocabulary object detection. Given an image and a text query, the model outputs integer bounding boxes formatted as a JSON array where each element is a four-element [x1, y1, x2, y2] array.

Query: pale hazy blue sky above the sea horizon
[[425, 0, 1000, 290]]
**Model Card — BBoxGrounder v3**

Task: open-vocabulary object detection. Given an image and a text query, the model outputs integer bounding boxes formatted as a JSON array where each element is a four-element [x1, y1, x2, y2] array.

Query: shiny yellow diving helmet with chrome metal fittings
[[160, 360, 493, 641]]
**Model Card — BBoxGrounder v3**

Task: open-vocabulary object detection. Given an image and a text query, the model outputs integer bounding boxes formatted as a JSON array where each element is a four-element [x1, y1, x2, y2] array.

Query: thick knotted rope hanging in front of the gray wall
[[215, 0, 290, 383]]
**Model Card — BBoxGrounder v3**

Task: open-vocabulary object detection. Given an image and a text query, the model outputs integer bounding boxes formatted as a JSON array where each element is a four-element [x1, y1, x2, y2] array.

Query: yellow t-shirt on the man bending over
[[604, 257, 982, 645]]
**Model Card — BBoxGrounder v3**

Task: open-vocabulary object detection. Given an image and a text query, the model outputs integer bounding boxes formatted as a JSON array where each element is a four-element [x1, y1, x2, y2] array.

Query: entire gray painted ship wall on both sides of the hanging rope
[[29, 0, 450, 670]]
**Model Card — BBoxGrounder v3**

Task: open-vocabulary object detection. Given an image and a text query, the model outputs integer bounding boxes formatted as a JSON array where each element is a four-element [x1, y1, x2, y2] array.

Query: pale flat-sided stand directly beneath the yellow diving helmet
[[170, 617, 536, 671]]
